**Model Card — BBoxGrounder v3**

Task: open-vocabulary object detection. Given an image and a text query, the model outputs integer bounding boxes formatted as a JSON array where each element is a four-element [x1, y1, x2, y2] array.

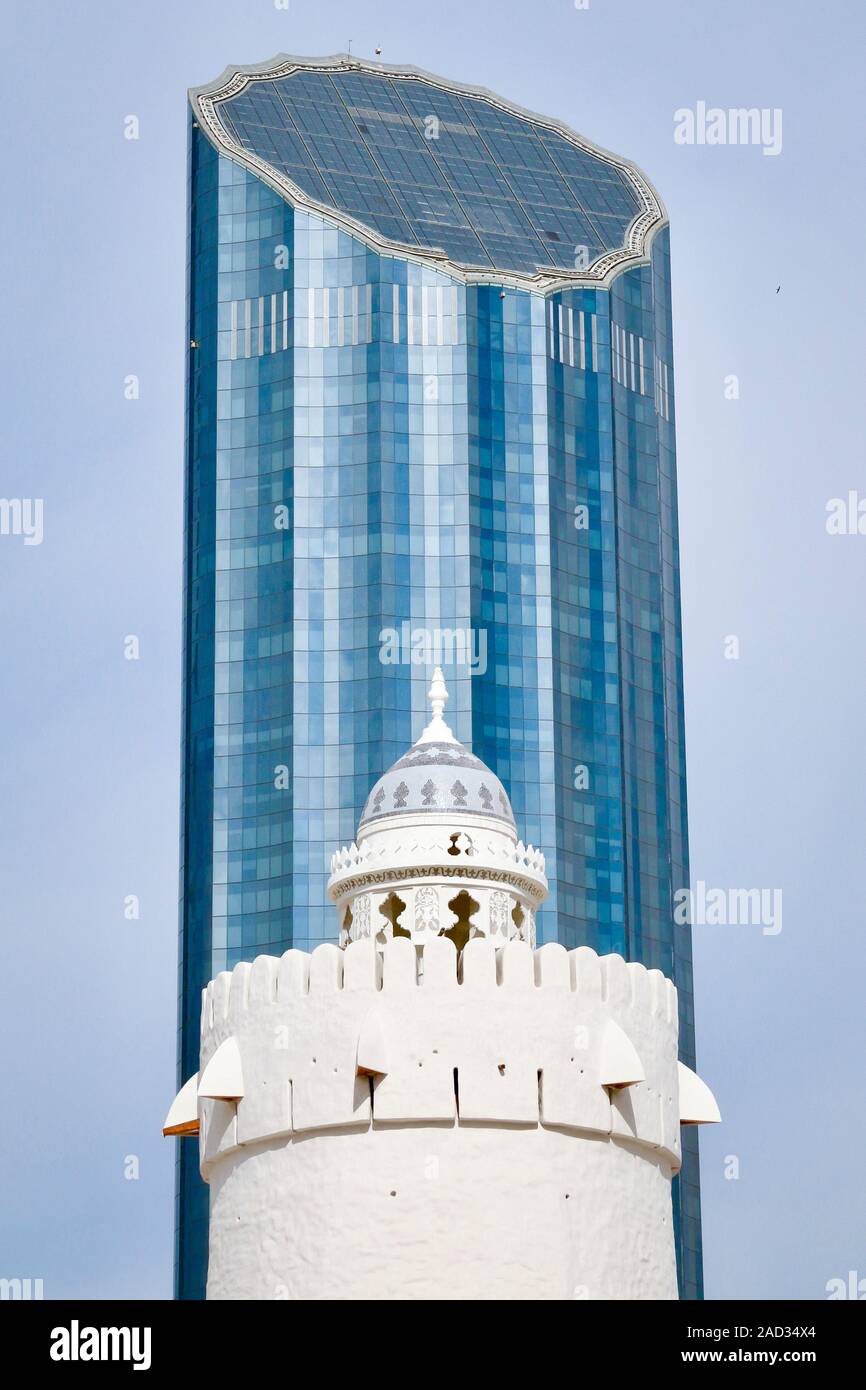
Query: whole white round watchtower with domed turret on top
[[165, 670, 719, 1301]]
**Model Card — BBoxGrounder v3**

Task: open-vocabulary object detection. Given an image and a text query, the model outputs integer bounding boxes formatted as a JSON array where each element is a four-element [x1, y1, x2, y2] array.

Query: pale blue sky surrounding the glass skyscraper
[[0, 0, 866, 1298]]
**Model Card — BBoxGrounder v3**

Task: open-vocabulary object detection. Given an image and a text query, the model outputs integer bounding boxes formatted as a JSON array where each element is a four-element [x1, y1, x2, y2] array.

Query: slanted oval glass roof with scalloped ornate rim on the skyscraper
[[190, 56, 664, 284]]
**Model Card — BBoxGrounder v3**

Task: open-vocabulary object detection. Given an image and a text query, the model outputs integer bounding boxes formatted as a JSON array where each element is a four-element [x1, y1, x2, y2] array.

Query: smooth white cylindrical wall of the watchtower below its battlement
[[207, 1122, 677, 1302]]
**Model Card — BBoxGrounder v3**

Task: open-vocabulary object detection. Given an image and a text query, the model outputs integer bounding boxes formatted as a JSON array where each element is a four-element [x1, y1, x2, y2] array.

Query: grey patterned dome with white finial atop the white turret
[[359, 667, 514, 831]]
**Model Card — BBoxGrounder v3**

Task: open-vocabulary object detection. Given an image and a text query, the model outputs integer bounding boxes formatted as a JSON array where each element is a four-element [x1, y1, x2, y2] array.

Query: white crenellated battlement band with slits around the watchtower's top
[[199, 937, 680, 1179]]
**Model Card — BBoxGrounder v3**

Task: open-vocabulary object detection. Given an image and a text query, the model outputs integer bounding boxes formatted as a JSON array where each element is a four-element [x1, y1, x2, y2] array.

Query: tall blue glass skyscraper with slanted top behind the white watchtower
[[177, 57, 701, 1298]]
